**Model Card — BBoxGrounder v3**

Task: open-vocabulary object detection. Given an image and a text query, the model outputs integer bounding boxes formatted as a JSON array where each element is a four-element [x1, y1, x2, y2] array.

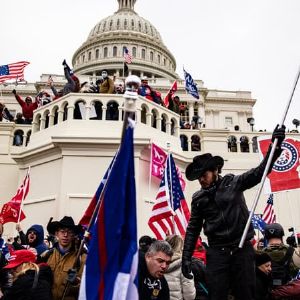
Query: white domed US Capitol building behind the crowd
[[0, 0, 300, 236]]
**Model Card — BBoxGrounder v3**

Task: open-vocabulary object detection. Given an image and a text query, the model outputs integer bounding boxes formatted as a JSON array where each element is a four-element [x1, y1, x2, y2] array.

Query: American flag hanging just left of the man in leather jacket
[[148, 154, 190, 240]]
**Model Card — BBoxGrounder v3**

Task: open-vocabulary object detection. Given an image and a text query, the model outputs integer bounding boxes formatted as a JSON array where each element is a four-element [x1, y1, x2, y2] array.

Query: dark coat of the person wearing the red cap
[[1, 265, 52, 300]]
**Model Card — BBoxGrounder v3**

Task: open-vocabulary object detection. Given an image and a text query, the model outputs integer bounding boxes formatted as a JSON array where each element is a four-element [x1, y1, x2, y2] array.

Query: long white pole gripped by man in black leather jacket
[[239, 67, 300, 248]]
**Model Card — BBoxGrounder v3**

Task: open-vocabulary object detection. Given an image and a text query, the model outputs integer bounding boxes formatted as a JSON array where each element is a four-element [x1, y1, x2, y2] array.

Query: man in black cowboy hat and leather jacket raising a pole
[[182, 126, 285, 300]]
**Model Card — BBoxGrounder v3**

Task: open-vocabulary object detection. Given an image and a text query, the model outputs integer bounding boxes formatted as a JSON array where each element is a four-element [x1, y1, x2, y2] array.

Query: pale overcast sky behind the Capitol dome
[[0, 0, 300, 130]]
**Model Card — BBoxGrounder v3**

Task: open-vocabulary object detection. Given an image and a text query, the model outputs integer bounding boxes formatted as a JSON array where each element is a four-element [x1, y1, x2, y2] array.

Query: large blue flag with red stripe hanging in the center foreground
[[78, 127, 139, 300]]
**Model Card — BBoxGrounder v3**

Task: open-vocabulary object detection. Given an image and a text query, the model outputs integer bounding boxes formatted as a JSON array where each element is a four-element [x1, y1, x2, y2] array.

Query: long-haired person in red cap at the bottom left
[[1, 250, 52, 300]]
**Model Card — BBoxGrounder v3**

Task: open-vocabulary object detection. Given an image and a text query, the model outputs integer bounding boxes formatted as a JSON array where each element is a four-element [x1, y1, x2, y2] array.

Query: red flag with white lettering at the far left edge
[[0, 170, 30, 224]]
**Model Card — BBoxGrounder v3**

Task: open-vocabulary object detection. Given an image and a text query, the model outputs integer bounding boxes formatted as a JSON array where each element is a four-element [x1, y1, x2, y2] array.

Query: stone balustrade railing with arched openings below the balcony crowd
[[32, 93, 179, 137]]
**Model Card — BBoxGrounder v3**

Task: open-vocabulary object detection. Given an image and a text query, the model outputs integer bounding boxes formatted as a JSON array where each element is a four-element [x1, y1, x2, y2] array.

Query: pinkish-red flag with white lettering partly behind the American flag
[[150, 143, 186, 191]]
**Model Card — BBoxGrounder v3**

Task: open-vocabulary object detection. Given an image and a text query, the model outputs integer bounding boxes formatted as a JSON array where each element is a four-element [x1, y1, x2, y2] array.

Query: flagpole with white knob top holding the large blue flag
[[61, 75, 141, 300]]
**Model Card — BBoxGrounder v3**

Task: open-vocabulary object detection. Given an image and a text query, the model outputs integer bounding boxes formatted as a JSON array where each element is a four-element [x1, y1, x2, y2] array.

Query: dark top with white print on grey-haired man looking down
[[138, 253, 170, 300]]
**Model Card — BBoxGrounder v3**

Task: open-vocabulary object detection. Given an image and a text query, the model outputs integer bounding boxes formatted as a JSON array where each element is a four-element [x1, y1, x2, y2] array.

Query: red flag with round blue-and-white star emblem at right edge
[[258, 138, 300, 193]]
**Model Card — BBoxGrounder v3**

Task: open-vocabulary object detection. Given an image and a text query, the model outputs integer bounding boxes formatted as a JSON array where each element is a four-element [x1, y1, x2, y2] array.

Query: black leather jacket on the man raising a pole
[[183, 149, 281, 260]]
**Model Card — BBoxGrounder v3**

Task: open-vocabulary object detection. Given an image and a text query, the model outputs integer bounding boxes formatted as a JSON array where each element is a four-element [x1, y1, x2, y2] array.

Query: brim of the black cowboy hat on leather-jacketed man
[[185, 156, 224, 181]]
